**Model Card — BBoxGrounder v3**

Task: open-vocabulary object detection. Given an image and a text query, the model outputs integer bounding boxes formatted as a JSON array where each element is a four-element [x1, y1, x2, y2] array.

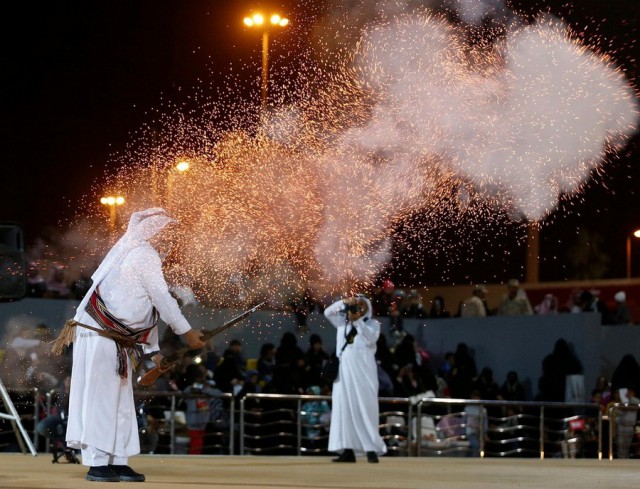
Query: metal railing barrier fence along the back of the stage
[[0, 388, 640, 460]]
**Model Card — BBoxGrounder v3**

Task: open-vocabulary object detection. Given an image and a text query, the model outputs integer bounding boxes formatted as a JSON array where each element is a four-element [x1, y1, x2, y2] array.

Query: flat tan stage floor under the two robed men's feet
[[0, 453, 640, 489]]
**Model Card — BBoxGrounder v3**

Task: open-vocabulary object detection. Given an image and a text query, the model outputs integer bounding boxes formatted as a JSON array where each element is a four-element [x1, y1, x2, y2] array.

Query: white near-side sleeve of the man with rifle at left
[[135, 247, 191, 335]]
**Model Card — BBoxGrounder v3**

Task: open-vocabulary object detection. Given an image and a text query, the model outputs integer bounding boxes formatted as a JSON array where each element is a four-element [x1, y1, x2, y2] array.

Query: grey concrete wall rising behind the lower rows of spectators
[[0, 299, 640, 399]]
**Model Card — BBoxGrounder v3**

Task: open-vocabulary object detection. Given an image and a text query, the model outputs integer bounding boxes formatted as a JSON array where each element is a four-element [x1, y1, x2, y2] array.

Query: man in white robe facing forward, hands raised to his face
[[324, 295, 387, 463]]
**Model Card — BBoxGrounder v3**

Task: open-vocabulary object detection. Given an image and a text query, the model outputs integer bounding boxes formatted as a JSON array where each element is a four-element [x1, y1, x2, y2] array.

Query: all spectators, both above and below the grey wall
[[2, 262, 640, 453]]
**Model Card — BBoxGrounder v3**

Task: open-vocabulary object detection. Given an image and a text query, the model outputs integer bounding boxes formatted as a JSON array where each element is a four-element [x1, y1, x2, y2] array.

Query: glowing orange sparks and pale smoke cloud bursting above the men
[[60, 7, 638, 306]]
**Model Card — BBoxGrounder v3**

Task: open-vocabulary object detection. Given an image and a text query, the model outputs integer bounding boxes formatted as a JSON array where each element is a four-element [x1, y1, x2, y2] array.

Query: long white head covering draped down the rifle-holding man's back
[[74, 207, 175, 321]]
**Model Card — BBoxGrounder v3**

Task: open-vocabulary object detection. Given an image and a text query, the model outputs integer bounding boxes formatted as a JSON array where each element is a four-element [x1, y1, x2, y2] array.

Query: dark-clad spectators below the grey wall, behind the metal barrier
[[1, 314, 640, 458]]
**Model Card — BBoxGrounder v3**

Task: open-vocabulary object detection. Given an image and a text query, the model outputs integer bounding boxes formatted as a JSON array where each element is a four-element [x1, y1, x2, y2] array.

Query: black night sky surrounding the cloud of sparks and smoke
[[0, 0, 640, 281]]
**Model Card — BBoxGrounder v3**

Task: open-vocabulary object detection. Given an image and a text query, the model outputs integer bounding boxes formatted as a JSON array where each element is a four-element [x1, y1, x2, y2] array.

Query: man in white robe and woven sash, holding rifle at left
[[56, 208, 204, 482]]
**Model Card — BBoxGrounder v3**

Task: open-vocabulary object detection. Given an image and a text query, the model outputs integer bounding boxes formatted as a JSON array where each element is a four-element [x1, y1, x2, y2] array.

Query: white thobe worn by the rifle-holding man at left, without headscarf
[[66, 242, 191, 465]]
